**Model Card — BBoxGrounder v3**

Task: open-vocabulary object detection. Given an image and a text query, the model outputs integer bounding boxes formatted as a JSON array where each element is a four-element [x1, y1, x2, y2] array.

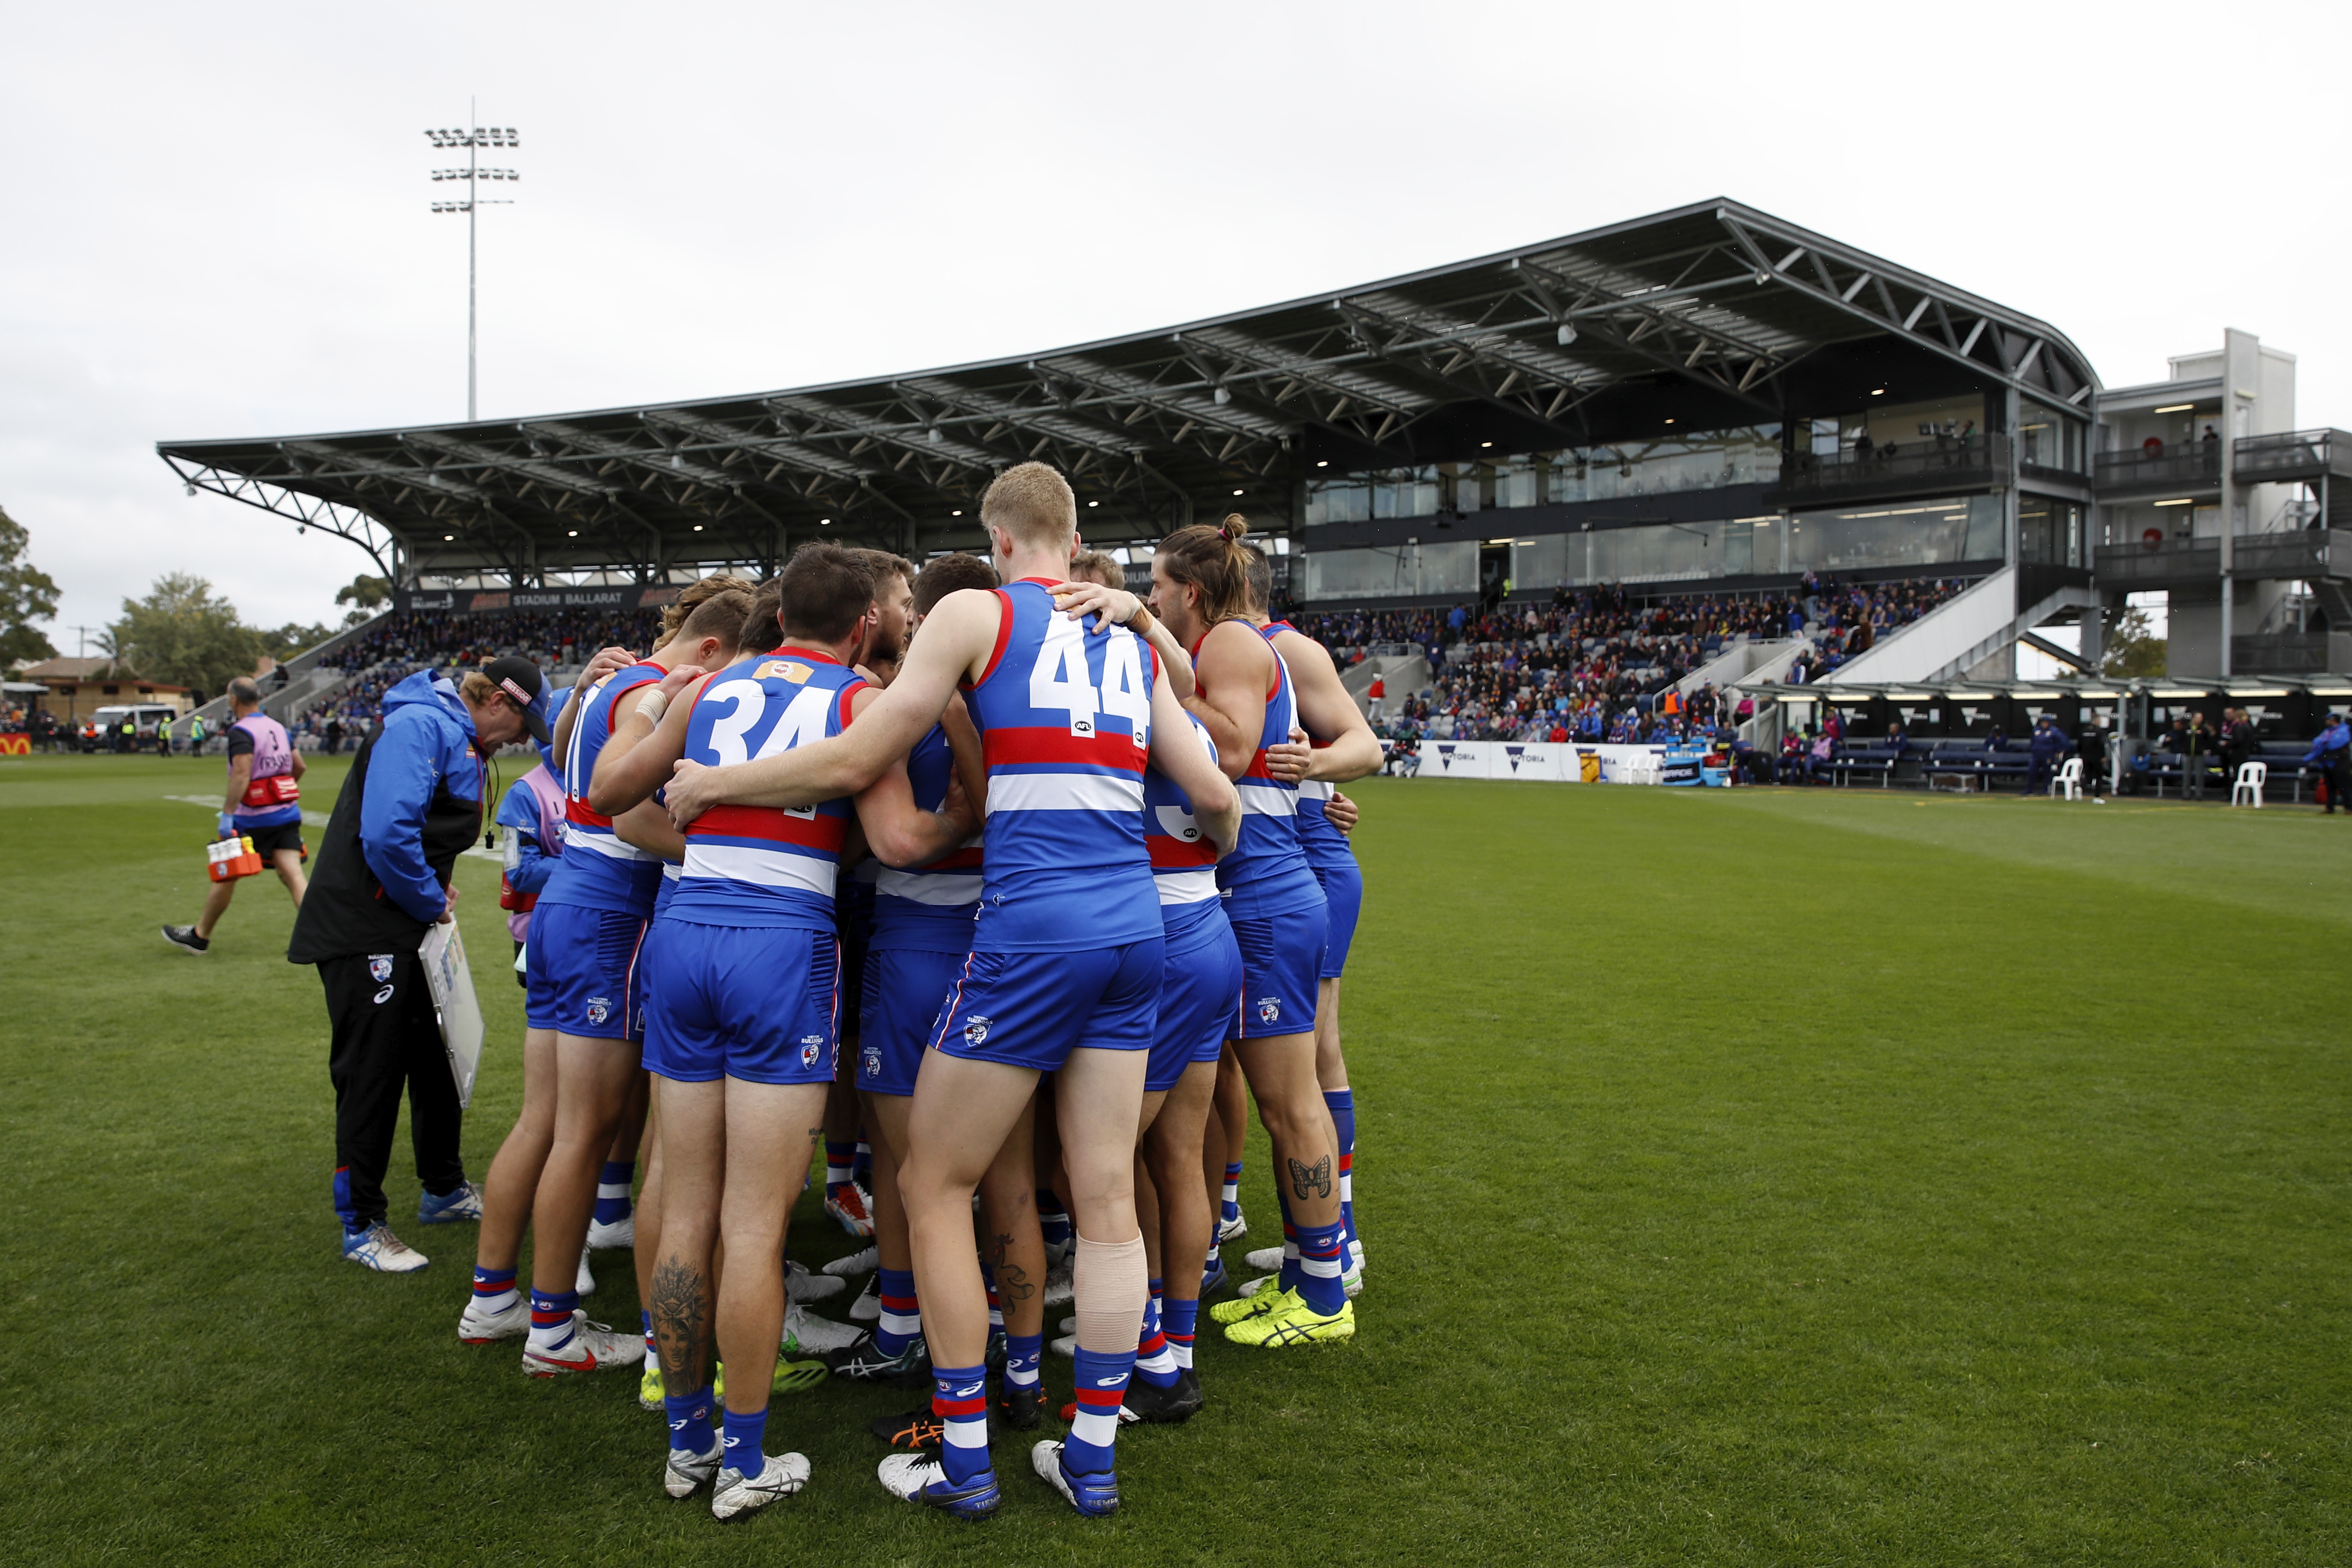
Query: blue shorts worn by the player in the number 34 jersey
[[644, 917, 842, 1084]]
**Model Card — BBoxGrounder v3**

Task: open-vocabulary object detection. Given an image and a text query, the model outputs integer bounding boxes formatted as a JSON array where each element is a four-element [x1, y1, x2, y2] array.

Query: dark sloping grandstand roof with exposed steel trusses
[[157, 200, 2098, 583]]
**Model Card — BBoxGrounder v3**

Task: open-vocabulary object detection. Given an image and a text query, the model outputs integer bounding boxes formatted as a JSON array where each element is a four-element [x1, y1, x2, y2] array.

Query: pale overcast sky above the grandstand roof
[[0, 0, 2352, 654]]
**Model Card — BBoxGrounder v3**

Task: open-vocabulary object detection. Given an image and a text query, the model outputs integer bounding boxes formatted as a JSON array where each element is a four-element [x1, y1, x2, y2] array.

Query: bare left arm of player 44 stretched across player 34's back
[[665, 588, 1002, 825]]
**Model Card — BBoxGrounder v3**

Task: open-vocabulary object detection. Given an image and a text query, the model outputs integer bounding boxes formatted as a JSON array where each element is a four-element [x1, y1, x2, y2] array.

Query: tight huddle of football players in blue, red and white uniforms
[[442, 463, 1381, 1519]]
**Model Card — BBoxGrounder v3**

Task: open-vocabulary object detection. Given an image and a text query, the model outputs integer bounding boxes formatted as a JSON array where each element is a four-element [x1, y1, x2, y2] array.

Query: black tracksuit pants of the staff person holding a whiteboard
[[318, 952, 466, 1230]]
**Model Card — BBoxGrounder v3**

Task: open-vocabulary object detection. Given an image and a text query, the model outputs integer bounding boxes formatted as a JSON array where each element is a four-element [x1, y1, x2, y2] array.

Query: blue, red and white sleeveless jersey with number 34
[[663, 647, 866, 936]]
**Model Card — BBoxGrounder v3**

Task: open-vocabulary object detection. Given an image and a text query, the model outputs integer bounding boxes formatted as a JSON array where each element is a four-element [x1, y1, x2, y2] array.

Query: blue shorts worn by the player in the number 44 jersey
[[932, 936, 1166, 1072]]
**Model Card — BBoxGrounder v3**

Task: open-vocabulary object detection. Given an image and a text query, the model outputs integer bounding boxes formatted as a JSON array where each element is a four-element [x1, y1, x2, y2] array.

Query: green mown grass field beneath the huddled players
[[0, 757, 2352, 1568]]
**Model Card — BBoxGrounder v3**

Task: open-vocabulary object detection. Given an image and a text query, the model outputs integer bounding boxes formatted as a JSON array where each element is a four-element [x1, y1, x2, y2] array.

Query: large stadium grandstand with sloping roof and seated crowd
[[157, 200, 2352, 780]]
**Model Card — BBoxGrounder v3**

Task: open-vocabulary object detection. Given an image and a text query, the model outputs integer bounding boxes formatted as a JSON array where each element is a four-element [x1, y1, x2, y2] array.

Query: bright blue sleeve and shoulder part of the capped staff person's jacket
[[360, 670, 482, 921]]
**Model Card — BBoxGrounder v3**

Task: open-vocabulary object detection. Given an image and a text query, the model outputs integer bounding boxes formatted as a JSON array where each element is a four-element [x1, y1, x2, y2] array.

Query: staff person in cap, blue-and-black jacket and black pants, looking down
[[287, 656, 548, 1274]]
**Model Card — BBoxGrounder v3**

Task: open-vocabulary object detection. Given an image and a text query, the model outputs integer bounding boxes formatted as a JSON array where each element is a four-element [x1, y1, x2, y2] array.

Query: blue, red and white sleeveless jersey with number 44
[[964, 578, 1159, 952]]
